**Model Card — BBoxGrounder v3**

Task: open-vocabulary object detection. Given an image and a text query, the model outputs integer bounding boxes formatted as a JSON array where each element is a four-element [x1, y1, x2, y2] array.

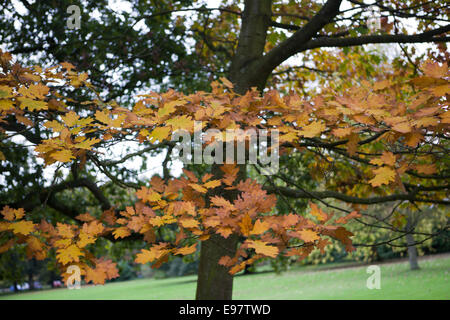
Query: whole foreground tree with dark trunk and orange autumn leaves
[[2, 0, 450, 299]]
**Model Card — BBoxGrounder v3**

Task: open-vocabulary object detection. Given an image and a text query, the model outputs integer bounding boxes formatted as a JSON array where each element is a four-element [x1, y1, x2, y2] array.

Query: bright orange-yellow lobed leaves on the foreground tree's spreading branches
[[0, 49, 450, 283]]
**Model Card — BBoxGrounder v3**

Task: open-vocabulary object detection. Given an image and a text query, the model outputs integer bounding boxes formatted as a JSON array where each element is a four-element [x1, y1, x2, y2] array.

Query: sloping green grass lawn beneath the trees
[[0, 255, 450, 300]]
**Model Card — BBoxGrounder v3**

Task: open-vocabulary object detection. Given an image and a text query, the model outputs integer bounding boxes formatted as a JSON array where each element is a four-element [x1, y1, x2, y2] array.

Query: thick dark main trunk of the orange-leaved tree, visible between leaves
[[196, 0, 272, 300]]
